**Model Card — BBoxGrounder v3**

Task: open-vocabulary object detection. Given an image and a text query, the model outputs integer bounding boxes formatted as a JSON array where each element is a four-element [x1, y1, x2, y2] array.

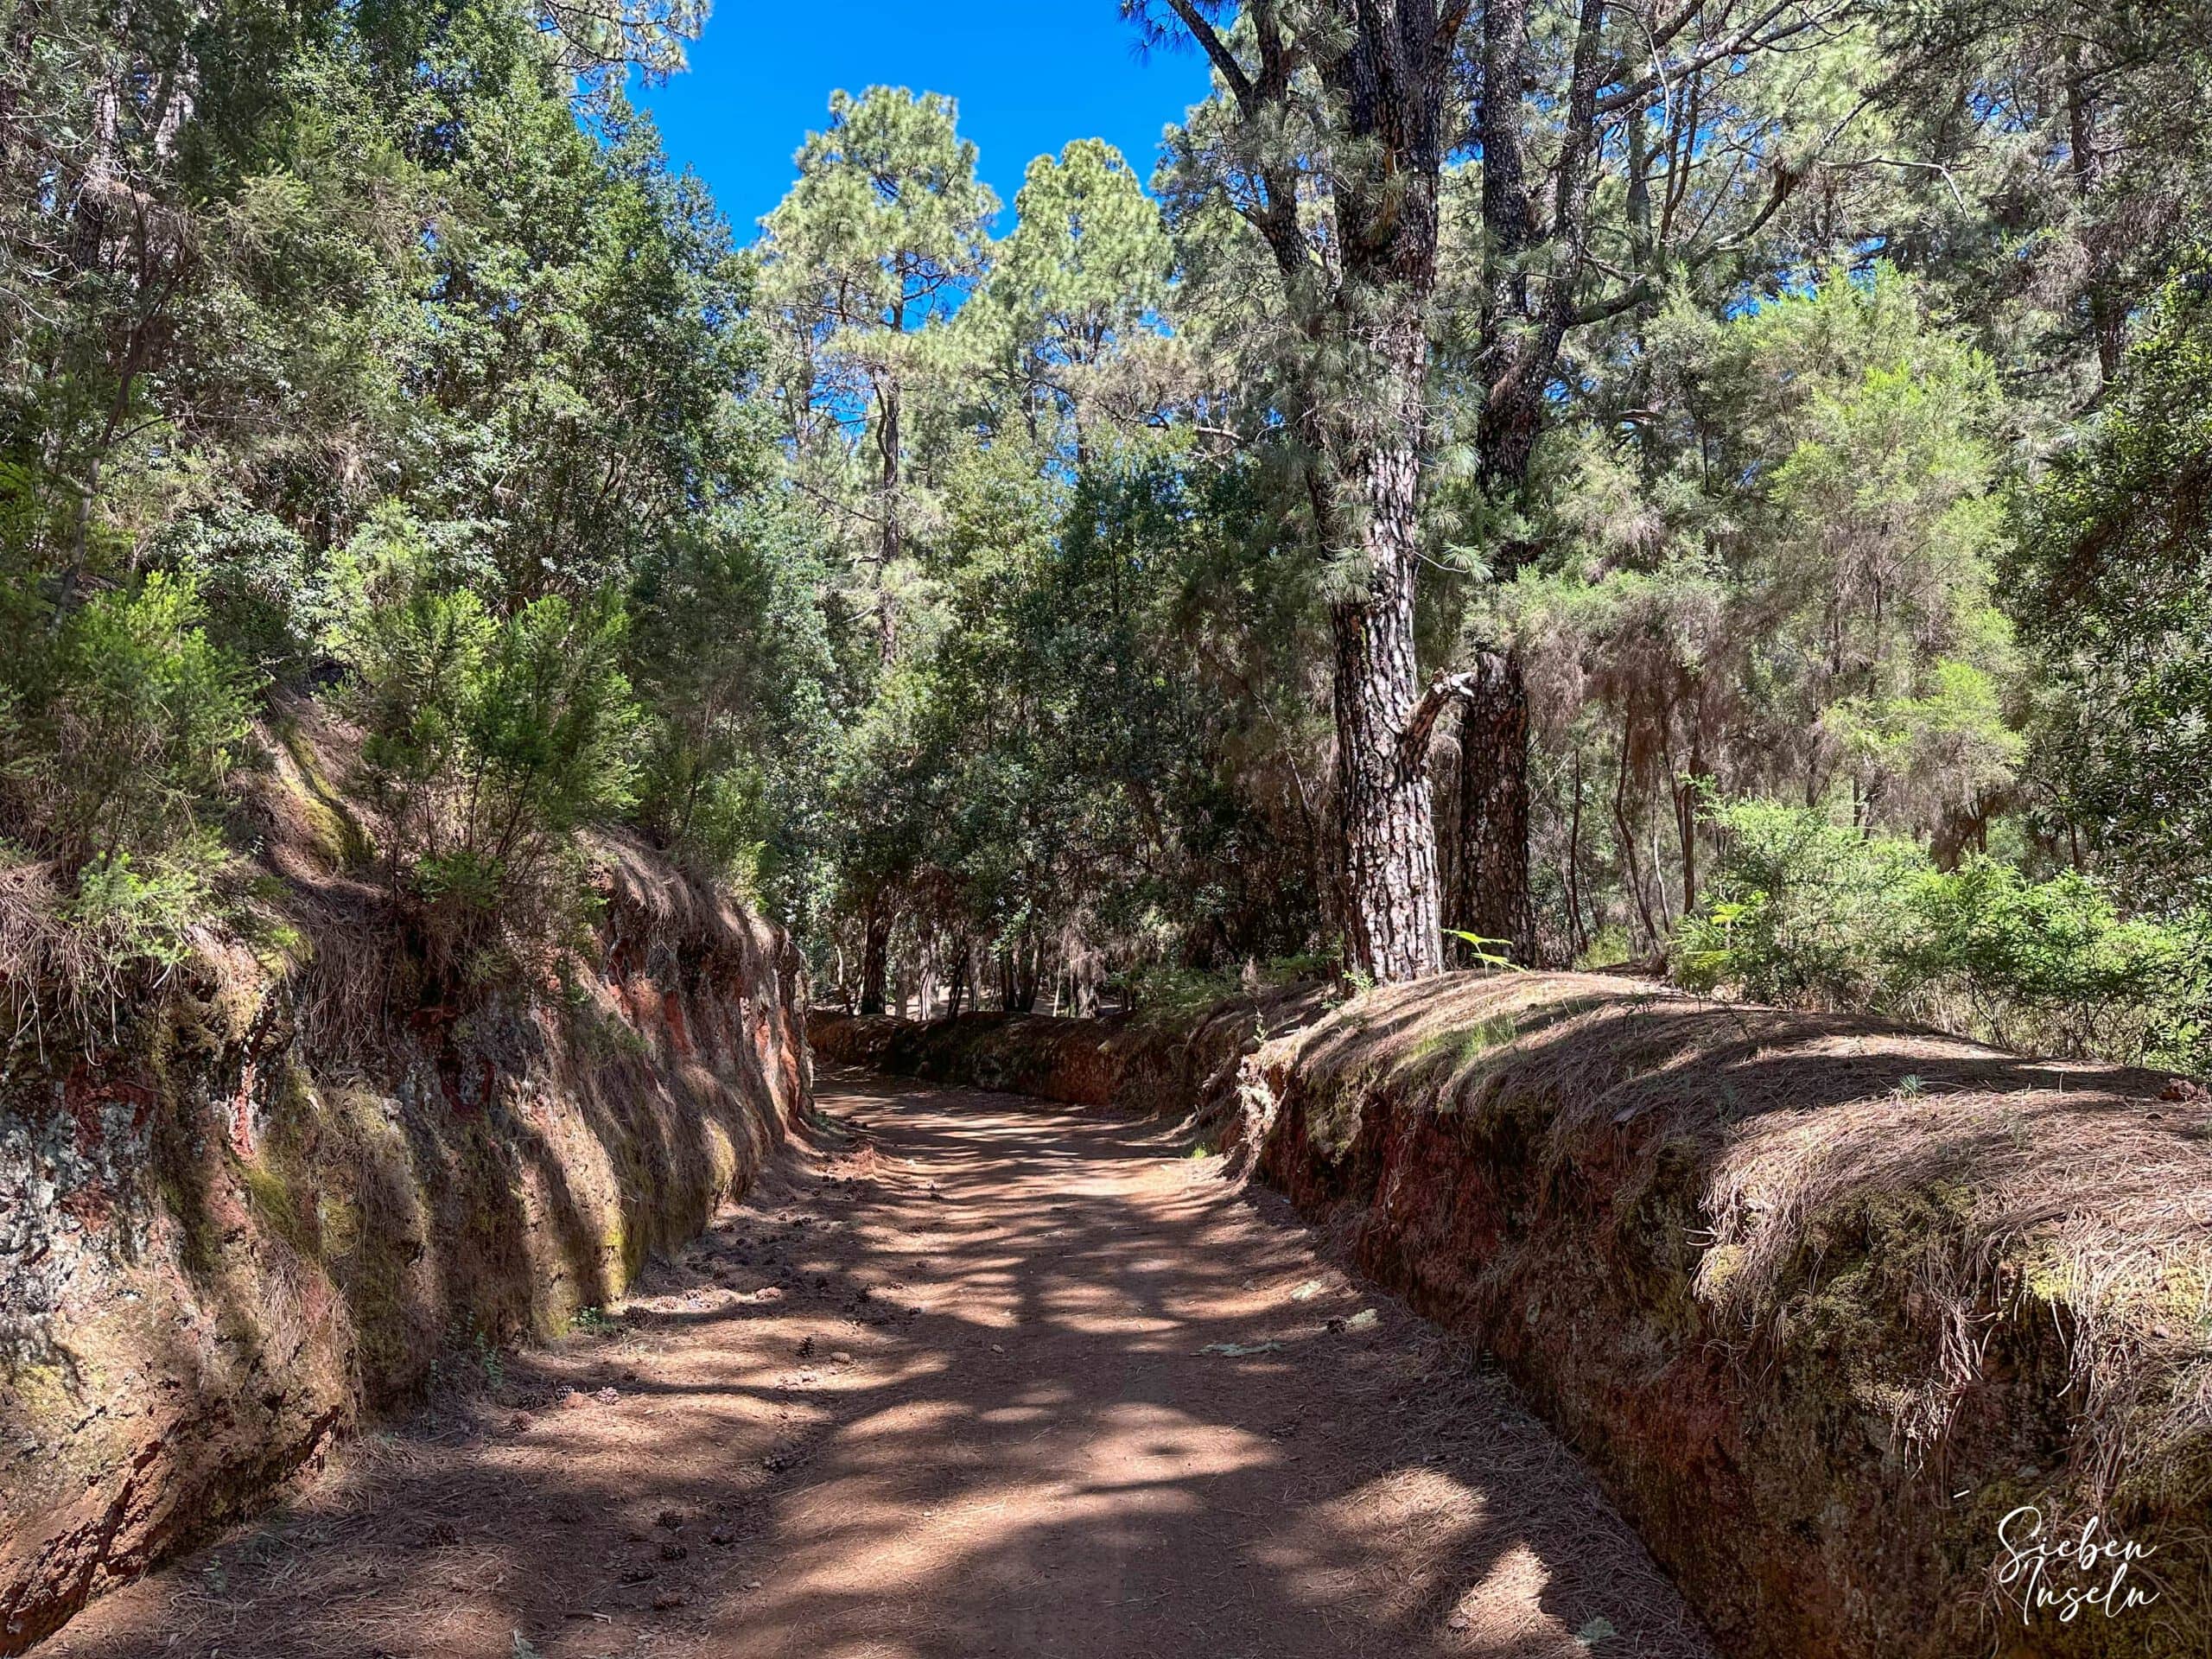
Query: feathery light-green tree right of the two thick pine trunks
[[1496, 265, 2024, 957]]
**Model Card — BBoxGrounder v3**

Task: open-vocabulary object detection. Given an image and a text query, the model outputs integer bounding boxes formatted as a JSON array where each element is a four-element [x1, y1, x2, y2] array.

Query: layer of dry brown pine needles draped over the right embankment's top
[[1289, 976, 2212, 1502]]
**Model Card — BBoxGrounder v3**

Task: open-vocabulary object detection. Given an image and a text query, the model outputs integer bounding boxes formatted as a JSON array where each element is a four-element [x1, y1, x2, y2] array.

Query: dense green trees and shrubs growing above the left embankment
[[0, 0, 830, 1026]]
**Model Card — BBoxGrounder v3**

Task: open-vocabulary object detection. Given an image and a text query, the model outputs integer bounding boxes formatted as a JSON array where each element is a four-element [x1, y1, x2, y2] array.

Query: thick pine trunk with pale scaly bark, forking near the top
[[1174, 0, 1468, 982]]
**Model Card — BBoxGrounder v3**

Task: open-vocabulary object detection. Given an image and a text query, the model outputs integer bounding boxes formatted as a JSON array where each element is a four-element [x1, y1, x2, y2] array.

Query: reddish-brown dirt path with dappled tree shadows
[[38, 1075, 1707, 1659]]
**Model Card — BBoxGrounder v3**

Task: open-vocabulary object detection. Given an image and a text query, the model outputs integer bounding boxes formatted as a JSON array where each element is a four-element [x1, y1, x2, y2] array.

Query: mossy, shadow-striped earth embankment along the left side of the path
[[0, 841, 810, 1652]]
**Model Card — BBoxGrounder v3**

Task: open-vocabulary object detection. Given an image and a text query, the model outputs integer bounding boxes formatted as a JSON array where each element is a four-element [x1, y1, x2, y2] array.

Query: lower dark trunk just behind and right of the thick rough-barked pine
[[1445, 657, 1535, 967]]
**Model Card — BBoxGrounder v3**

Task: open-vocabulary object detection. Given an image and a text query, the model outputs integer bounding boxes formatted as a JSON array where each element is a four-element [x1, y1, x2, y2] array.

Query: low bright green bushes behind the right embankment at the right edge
[[1675, 801, 2212, 1071]]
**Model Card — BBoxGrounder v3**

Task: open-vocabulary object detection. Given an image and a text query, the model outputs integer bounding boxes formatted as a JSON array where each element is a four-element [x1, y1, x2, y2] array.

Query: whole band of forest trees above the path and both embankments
[[13, 0, 2212, 1058]]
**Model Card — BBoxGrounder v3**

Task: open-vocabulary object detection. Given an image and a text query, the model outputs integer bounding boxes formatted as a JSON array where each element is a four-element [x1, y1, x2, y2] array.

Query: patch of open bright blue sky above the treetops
[[637, 0, 1205, 238]]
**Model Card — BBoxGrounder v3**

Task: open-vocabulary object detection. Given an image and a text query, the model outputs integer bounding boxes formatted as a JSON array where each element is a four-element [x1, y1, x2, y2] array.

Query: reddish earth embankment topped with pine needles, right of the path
[[809, 976, 2212, 1659]]
